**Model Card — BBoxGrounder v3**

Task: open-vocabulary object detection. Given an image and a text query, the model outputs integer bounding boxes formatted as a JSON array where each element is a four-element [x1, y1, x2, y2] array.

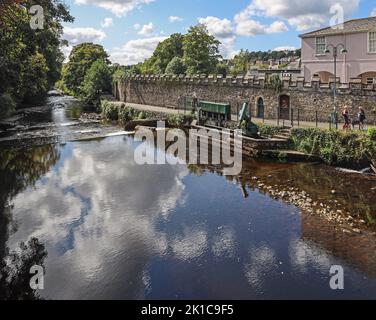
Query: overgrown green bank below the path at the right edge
[[291, 129, 376, 169]]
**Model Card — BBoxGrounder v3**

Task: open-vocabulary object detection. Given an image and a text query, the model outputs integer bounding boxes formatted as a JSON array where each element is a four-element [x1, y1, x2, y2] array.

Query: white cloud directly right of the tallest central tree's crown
[[198, 16, 236, 58]]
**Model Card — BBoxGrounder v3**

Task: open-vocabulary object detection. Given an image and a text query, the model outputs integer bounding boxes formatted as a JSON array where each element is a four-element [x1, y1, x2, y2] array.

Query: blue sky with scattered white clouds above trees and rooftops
[[64, 0, 376, 64]]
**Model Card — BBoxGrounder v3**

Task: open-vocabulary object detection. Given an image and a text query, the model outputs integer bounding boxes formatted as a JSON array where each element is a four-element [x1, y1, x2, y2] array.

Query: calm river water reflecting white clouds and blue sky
[[0, 94, 376, 299]]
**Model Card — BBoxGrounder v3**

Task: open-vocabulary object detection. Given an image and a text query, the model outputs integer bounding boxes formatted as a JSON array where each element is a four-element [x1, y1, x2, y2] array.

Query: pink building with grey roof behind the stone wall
[[300, 17, 376, 84]]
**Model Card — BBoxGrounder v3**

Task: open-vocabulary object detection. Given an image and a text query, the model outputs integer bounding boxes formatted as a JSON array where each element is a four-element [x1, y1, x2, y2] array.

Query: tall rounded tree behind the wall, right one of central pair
[[183, 24, 221, 74]]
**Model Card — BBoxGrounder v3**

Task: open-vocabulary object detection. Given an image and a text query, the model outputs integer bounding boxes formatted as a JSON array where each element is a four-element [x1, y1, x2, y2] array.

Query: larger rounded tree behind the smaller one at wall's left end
[[62, 43, 109, 96]]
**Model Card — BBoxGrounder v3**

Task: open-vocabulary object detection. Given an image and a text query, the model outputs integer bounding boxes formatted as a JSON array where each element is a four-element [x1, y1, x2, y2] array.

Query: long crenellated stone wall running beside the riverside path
[[113, 76, 376, 123]]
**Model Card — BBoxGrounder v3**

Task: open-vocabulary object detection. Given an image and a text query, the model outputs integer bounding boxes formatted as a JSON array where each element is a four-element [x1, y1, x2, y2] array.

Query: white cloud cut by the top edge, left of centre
[[74, 0, 155, 16]]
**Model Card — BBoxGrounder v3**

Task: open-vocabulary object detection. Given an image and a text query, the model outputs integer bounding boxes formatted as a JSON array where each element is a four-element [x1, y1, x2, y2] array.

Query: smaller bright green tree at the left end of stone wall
[[80, 60, 112, 105]]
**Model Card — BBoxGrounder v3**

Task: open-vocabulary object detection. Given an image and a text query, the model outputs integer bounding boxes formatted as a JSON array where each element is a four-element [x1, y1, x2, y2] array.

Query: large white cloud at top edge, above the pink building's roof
[[239, 0, 360, 31]]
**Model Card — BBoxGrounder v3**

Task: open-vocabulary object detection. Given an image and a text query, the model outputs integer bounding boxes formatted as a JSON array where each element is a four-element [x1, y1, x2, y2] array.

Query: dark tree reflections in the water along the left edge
[[0, 145, 60, 300]]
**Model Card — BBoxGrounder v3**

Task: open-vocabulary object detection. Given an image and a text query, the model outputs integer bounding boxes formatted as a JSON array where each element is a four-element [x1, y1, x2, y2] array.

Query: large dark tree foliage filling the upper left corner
[[0, 0, 73, 114]]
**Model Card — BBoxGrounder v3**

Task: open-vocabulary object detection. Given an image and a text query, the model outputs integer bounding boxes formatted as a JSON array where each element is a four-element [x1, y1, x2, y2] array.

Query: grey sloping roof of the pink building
[[300, 17, 376, 38]]
